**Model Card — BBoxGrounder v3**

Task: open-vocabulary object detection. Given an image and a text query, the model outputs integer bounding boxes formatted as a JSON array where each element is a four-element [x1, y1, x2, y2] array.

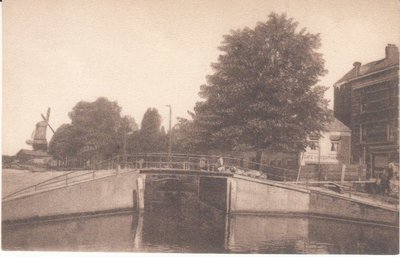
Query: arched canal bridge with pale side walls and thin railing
[[2, 153, 398, 224]]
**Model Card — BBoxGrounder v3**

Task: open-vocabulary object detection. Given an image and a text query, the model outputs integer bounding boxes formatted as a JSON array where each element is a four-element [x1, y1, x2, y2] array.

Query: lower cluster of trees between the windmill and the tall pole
[[49, 97, 168, 165]]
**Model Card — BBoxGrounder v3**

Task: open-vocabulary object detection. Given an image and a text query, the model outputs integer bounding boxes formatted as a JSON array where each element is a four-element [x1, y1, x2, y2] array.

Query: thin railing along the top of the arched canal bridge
[[3, 153, 297, 200]]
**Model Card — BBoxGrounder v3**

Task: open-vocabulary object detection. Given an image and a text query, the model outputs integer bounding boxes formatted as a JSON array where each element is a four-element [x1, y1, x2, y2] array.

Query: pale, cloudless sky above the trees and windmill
[[2, 0, 400, 155]]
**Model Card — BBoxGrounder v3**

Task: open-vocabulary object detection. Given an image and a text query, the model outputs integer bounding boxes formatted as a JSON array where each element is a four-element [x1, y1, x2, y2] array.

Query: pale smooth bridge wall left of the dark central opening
[[2, 169, 138, 221]]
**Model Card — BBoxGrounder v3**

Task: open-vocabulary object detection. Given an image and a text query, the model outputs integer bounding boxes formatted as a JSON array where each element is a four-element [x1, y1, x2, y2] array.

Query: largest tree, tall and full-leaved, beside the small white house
[[193, 13, 328, 151]]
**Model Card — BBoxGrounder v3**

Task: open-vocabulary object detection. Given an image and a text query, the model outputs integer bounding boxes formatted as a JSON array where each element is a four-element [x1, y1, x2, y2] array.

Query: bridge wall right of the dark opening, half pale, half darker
[[230, 175, 399, 226]]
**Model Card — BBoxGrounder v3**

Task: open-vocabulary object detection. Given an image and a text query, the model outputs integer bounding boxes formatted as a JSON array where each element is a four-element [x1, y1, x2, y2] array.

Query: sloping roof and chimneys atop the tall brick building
[[334, 44, 399, 86]]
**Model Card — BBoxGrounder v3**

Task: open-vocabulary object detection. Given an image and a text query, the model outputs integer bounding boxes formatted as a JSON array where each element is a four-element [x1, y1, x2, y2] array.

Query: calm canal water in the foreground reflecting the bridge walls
[[2, 208, 399, 254]]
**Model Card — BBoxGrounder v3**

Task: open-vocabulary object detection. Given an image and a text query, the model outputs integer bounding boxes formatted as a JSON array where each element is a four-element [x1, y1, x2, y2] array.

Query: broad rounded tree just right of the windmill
[[49, 97, 142, 165]]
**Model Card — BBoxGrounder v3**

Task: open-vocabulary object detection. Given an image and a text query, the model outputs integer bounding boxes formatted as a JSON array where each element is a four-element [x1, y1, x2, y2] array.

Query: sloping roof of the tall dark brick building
[[335, 44, 399, 85]]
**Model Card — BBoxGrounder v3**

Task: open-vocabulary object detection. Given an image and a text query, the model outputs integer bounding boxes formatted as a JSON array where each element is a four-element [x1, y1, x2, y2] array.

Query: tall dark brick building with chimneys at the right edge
[[334, 44, 399, 176]]
